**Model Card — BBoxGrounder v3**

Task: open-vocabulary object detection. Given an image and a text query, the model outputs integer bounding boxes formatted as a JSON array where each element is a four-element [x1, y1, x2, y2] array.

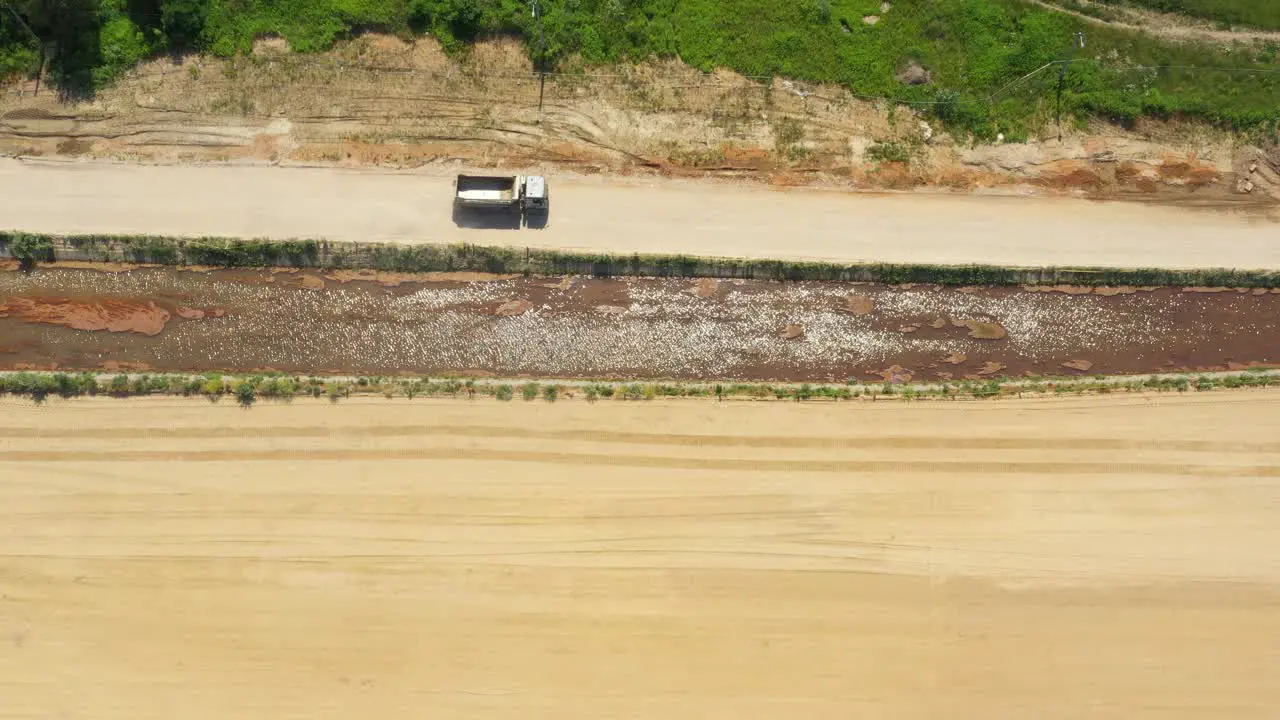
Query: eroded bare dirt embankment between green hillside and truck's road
[[0, 36, 1280, 204]]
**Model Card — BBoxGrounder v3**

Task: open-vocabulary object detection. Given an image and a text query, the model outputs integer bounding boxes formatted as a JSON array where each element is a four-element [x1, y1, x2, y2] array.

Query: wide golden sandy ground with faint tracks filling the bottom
[[0, 393, 1280, 720]]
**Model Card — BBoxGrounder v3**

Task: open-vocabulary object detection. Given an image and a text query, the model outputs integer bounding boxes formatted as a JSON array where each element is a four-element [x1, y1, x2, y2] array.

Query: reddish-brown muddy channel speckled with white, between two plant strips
[[0, 268, 1280, 382]]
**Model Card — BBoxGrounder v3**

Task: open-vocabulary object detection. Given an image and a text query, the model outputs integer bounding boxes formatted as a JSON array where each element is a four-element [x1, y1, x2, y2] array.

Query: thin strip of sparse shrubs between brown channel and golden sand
[[0, 369, 1280, 406]]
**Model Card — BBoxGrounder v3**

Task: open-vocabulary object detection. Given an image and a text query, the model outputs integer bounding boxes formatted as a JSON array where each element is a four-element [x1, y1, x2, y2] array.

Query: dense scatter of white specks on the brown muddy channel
[[0, 270, 1206, 378]]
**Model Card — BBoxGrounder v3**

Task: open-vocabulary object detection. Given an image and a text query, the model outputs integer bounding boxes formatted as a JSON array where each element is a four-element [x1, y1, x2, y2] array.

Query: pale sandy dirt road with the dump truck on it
[[0, 160, 1280, 268]]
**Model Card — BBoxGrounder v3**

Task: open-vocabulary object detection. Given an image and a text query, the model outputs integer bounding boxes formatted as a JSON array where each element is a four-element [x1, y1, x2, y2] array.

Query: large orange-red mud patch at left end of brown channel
[[0, 297, 170, 336]]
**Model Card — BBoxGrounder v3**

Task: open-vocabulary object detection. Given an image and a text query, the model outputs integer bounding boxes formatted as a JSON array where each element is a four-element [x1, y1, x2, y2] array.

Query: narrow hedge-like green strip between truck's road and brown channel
[[0, 231, 1280, 288]]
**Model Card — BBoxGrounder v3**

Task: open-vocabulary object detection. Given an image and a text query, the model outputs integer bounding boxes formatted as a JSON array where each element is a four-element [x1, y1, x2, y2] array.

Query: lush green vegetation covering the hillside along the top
[[0, 0, 1280, 140]]
